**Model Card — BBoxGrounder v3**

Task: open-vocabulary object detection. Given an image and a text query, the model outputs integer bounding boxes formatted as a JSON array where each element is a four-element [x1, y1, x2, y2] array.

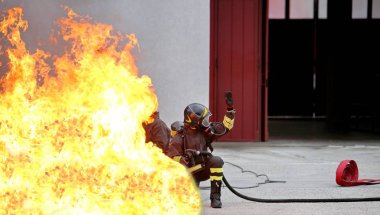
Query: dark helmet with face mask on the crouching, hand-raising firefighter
[[183, 103, 212, 129]]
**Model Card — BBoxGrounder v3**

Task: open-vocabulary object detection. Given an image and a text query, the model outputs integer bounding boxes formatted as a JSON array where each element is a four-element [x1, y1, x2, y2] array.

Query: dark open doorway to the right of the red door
[[268, 0, 380, 137]]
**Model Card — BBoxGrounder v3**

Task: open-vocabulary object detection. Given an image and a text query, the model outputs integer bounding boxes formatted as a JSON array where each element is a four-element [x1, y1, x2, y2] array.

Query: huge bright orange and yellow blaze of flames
[[0, 5, 201, 214]]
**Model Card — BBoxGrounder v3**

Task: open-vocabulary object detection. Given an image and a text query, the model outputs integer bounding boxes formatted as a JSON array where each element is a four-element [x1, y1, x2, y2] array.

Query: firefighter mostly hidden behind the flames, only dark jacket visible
[[143, 111, 170, 153]]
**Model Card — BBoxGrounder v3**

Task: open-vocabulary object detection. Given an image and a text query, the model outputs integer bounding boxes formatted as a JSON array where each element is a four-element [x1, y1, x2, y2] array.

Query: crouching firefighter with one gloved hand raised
[[167, 92, 235, 208]]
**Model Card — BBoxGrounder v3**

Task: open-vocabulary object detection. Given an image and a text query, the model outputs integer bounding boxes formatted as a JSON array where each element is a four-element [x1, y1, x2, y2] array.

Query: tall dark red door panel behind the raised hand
[[210, 0, 267, 141]]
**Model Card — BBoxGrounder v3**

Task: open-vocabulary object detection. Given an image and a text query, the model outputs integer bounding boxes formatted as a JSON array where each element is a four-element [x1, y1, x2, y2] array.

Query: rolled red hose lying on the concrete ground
[[336, 160, 380, 187]]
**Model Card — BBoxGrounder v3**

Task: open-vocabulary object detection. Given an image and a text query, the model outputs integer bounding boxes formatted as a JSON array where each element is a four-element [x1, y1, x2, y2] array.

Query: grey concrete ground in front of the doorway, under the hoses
[[200, 121, 380, 215]]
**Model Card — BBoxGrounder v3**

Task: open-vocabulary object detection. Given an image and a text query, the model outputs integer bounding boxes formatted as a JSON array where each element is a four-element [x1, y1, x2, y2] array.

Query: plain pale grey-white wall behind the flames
[[0, 0, 210, 126]]
